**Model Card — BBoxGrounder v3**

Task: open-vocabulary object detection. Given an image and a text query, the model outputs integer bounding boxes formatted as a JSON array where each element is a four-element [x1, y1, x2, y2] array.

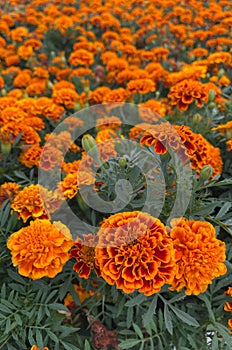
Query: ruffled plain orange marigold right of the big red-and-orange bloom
[[170, 219, 227, 295]]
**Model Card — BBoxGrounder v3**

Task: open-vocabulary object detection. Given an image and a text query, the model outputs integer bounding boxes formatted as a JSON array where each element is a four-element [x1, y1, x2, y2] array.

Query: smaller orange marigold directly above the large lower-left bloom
[[11, 184, 61, 222]]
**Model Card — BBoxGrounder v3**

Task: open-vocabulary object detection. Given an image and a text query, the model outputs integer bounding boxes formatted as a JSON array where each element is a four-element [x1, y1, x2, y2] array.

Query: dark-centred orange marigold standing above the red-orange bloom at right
[[168, 79, 208, 111]]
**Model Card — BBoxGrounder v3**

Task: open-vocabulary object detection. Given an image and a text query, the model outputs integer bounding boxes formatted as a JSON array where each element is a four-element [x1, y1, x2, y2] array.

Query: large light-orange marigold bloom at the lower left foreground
[[7, 219, 73, 280]]
